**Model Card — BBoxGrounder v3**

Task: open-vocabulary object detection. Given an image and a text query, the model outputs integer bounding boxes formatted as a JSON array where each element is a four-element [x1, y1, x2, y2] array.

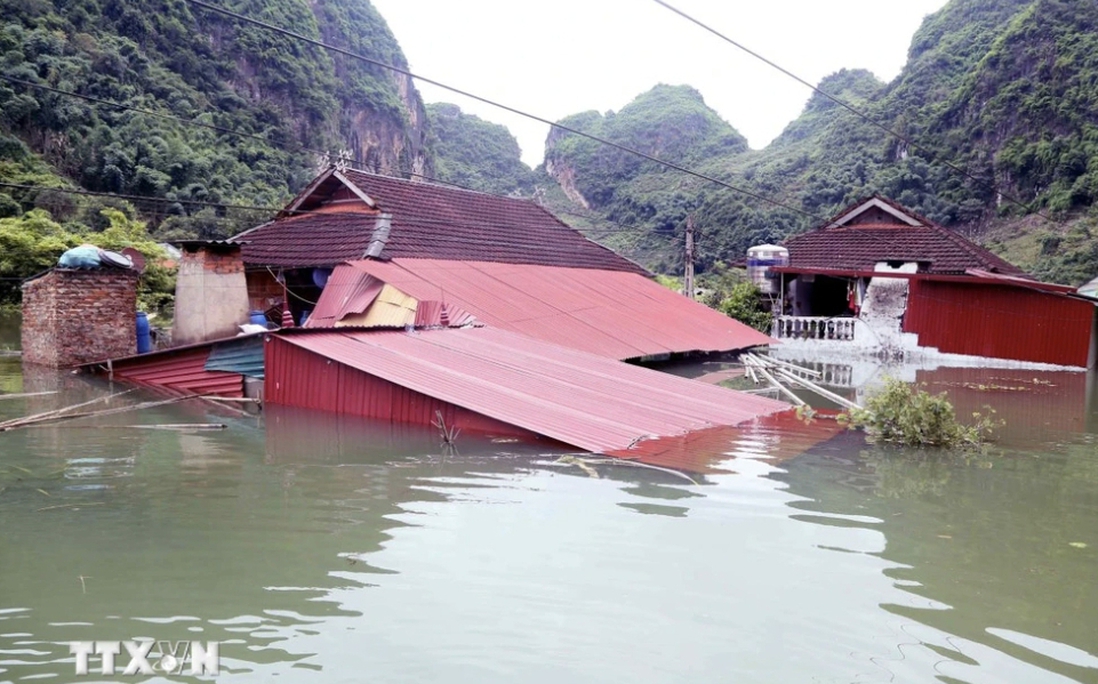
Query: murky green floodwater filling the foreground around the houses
[[0, 314, 1098, 684]]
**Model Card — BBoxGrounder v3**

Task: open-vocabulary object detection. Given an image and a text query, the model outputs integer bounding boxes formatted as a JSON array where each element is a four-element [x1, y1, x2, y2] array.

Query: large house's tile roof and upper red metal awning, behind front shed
[[233, 168, 773, 360]]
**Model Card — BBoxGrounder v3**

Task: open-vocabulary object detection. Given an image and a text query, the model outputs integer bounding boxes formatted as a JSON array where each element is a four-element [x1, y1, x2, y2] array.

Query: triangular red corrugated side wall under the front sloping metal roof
[[264, 337, 538, 439]]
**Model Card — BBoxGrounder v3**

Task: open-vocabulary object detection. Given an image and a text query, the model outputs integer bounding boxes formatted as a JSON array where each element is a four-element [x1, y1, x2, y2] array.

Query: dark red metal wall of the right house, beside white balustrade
[[904, 280, 1095, 367]]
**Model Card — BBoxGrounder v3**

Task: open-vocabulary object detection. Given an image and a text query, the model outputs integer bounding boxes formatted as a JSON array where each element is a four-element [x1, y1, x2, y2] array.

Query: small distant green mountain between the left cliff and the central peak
[[427, 103, 537, 195]]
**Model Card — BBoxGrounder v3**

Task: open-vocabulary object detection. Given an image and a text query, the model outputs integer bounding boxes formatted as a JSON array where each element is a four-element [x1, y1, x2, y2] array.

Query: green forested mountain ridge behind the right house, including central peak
[[547, 0, 1098, 282]]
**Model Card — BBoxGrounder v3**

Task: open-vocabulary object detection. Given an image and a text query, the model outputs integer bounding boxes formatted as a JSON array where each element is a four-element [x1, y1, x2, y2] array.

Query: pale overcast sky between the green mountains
[[371, 0, 945, 166]]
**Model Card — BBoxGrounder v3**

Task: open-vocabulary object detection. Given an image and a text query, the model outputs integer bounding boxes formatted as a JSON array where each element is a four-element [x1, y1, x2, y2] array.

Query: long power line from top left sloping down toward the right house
[[187, 0, 819, 222]]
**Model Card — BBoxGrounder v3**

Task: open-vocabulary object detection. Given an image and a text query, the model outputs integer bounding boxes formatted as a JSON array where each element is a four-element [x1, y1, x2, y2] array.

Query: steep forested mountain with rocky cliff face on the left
[[0, 0, 432, 236]]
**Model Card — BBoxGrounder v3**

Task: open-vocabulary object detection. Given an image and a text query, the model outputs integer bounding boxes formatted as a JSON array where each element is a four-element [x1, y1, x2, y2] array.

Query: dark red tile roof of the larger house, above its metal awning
[[236, 171, 647, 273]]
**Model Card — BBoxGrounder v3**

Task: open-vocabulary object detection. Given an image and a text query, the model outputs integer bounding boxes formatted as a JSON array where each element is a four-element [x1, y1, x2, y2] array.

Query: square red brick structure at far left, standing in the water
[[22, 269, 137, 367]]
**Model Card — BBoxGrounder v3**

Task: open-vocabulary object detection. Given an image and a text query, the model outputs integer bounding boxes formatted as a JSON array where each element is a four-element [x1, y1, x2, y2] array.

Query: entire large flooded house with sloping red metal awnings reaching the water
[[83, 169, 788, 463]]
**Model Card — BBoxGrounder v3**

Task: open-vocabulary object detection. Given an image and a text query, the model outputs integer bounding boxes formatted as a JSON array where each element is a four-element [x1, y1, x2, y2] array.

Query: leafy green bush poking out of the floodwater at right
[[840, 378, 996, 449]]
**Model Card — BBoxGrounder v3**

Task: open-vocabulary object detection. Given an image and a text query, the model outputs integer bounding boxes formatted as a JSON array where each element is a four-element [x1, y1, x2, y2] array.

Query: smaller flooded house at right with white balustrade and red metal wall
[[770, 197, 1098, 368]]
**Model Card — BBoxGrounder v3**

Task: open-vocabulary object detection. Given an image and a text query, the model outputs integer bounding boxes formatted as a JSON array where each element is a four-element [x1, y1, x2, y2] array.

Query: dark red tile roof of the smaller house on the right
[[783, 198, 1026, 276]]
